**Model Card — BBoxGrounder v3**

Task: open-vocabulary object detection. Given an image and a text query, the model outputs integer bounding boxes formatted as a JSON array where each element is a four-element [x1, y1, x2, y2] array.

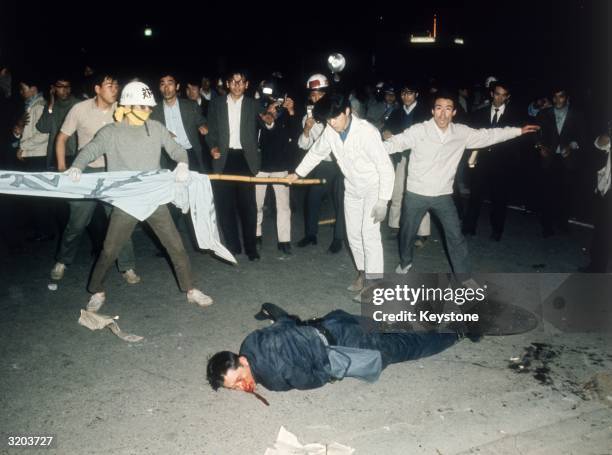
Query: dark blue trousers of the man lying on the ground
[[323, 310, 458, 368]]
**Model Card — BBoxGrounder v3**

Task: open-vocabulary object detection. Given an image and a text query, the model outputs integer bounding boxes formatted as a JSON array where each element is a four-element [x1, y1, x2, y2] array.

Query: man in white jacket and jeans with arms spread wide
[[385, 92, 539, 274]]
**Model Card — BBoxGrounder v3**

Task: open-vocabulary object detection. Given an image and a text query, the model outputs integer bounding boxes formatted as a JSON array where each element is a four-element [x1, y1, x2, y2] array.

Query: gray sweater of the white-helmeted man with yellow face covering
[[72, 120, 188, 172]]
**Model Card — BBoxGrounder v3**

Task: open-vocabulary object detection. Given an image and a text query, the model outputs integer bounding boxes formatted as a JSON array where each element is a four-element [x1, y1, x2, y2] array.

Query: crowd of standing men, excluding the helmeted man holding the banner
[[0, 62, 610, 291]]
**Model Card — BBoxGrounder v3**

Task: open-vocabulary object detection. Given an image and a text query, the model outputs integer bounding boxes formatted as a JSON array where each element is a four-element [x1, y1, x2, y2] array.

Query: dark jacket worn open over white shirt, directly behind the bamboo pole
[[206, 96, 261, 175]]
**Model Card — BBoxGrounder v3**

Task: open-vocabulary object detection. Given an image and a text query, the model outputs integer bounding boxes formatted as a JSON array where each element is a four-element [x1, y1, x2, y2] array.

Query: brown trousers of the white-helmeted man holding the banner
[[89, 205, 192, 293]]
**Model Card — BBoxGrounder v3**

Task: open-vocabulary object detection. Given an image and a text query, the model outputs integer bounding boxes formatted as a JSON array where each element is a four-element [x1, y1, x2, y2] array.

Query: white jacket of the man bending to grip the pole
[[295, 115, 396, 200]]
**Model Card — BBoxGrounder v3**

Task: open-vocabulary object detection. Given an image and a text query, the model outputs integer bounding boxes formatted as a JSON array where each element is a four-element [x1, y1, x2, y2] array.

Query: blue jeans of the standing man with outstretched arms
[[399, 191, 471, 273]]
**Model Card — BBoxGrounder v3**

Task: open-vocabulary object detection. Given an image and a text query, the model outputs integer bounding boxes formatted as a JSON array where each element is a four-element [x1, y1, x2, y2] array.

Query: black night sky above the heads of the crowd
[[0, 0, 610, 128]]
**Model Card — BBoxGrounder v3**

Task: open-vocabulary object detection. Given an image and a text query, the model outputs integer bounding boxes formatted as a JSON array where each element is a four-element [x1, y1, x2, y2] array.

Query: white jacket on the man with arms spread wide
[[385, 119, 521, 196]]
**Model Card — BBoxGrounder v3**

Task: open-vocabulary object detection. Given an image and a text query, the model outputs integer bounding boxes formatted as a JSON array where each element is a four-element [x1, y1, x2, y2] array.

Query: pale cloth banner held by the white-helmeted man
[[0, 170, 236, 263]]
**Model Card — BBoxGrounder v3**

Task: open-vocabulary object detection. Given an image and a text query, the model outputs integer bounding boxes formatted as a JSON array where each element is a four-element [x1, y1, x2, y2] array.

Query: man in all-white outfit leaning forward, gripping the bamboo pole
[[288, 94, 395, 291]]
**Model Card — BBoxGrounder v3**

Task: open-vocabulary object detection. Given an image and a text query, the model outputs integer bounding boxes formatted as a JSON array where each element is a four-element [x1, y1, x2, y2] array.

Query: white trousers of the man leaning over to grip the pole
[[344, 191, 385, 278]]
